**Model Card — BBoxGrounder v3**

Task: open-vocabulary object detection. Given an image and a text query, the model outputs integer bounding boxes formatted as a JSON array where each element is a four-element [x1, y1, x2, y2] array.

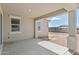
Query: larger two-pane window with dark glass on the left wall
[[11, 16, 21, 32]]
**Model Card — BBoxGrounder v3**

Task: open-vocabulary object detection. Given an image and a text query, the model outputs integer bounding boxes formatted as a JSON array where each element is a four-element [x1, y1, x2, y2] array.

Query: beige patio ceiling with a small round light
[[1, 3, 79, 18]]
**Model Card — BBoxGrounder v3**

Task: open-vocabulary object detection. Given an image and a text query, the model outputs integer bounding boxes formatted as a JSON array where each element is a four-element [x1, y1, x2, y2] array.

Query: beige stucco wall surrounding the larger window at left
[[3, 13, 34, 42]]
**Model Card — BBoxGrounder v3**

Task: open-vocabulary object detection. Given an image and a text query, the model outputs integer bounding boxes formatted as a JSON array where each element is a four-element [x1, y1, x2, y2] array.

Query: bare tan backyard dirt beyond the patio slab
[[48, 32, 79, 47]]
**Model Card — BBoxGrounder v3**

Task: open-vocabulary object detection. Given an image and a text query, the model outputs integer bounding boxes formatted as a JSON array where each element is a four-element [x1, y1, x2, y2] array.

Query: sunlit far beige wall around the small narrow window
[[35, 19, 48, 38]]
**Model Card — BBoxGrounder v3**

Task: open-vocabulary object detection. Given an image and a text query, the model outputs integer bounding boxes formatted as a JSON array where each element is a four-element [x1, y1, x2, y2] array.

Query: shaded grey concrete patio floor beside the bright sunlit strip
[[2, 39, 56, 55]]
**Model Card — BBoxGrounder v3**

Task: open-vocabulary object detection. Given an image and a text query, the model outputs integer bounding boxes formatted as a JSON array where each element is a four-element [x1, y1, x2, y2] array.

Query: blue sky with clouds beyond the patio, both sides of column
[[48, 10, 79, 27]]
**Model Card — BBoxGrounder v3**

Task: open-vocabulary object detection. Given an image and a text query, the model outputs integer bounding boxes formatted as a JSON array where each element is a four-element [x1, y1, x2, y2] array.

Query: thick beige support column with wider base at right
[[67, 10, 77, 50]]
